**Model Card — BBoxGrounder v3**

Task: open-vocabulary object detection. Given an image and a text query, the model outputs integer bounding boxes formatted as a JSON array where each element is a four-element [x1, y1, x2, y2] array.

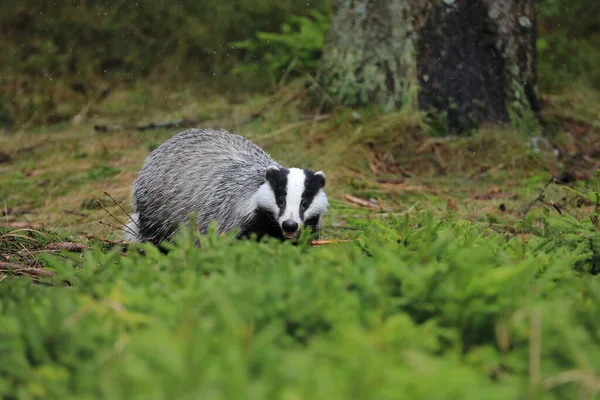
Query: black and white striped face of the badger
[[257, 166, 329, 239]]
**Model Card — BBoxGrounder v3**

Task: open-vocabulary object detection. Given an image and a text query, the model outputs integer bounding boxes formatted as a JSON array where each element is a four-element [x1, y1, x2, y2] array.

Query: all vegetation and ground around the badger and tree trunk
[[0, 0, 600, 399]]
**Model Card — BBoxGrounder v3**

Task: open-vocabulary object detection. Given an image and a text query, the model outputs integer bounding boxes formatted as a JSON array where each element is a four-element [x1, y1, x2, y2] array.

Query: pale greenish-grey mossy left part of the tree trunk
[[317, 0, 427, 111]]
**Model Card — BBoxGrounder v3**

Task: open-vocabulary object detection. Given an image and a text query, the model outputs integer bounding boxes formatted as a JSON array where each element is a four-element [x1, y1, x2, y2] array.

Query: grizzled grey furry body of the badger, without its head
[[133, 129, 281, 244]]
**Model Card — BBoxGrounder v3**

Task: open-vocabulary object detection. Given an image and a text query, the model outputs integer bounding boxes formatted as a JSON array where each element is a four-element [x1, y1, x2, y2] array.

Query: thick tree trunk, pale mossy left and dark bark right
[[317, 0, 539, 132]]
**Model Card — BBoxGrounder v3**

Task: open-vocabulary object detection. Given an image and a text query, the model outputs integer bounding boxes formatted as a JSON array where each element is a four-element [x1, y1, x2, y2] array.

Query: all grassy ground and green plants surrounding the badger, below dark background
[[0, 78, 600, 399]]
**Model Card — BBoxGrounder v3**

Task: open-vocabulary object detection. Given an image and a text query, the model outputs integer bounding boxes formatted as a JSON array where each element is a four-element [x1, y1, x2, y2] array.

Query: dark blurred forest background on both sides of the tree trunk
[[0, 0, 600, 128]]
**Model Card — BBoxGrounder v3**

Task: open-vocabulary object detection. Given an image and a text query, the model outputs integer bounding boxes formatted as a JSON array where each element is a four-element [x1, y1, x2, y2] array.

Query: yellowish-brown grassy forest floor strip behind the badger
[[0, 80, 600, 244]]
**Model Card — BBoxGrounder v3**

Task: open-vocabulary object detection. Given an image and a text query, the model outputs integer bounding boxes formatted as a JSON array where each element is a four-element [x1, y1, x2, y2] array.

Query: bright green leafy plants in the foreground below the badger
[[0, 212, 600, 399]]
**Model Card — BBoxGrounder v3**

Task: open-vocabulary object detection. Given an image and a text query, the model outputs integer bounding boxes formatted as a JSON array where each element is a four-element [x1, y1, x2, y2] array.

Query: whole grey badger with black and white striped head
[[125, 128, 329, 246]]
